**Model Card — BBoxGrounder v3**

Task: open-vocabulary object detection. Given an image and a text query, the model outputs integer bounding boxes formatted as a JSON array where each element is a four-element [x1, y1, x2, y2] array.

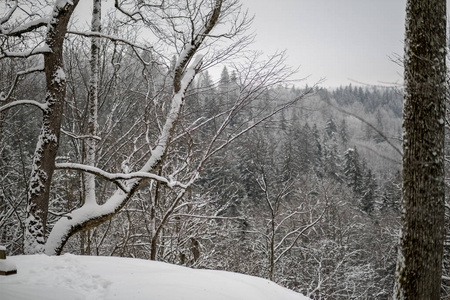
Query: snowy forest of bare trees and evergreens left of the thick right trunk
[[0, 0, 450, 299]]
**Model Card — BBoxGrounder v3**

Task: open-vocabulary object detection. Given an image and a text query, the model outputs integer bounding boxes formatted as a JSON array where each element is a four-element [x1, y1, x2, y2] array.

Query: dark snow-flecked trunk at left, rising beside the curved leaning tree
[[24, 0, 78, 254]]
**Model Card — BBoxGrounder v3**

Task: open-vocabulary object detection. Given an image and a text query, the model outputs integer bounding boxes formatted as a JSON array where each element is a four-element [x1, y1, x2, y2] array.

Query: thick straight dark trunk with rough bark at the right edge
[[394, 0, 447, 300]]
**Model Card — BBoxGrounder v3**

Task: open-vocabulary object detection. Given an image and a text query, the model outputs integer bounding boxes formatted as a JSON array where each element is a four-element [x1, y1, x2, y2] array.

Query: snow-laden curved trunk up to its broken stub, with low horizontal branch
[[45, 35, 202, 255]]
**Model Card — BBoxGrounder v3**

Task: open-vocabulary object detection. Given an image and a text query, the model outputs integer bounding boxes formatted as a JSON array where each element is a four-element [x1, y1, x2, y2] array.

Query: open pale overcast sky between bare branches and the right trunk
[[243, 0, 406, 87]]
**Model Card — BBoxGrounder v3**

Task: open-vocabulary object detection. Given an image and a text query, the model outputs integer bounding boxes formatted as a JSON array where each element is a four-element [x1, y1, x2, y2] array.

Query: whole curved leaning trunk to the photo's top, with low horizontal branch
[[45, 0, 223, 255]]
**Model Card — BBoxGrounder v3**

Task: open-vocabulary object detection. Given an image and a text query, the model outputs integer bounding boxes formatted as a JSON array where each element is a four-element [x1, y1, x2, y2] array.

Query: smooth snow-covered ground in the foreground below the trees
[[0, 254, 308, 300]]
